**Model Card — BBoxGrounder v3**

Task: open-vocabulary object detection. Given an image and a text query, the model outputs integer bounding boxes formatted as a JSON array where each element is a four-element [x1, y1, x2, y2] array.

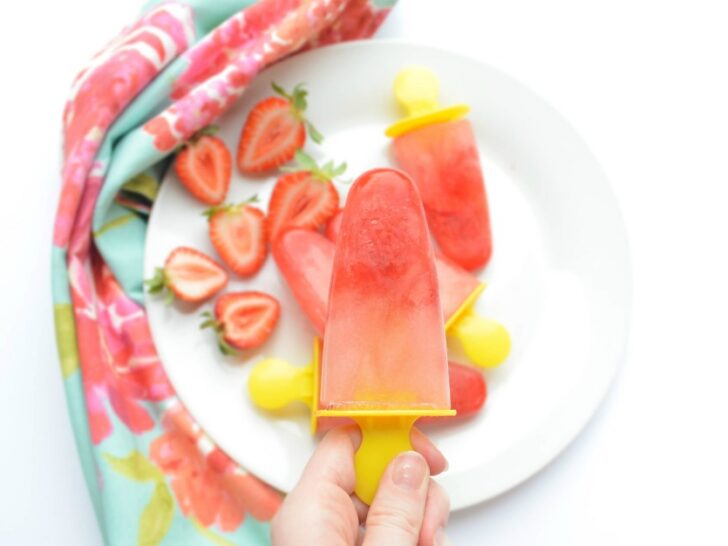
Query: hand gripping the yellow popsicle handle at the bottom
[[271, 426, 450, 546]]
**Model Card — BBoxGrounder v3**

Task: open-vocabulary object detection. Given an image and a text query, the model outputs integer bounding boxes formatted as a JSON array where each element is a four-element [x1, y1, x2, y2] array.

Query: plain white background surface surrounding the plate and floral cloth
[[0, 0, 728, 546]]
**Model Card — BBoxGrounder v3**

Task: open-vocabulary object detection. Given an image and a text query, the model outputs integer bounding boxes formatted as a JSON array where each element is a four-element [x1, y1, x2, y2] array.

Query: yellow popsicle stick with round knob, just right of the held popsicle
[[445, 283, 511, 368]]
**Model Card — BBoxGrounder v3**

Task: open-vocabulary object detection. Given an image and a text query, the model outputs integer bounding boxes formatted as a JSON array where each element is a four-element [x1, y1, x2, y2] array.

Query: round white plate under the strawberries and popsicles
[[145, 41, 630, 509]]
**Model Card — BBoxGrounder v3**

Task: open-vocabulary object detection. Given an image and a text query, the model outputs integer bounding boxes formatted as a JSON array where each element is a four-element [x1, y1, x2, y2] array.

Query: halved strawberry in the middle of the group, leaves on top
[[203, 196, 268, 277]]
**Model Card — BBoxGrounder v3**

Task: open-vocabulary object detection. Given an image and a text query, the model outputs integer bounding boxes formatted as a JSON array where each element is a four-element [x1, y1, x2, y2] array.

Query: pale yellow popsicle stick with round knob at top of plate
[[385, 66, 470, 138]]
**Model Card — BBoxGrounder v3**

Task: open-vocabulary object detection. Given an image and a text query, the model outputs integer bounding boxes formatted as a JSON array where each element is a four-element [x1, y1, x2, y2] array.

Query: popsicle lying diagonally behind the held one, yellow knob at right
[[273, 217, 511, 368]]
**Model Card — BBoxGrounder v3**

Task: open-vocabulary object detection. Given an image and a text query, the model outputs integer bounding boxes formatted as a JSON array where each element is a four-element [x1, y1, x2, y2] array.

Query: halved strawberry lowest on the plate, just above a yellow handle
[[200, 291, 281, 355]]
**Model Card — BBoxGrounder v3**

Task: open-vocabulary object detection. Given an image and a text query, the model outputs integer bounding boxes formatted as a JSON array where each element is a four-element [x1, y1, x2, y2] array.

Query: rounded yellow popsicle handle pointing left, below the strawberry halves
[[248, 358, 315, 410]]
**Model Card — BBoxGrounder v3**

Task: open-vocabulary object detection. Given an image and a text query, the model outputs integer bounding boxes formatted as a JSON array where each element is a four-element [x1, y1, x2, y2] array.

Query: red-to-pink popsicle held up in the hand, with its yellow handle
[[317, 169, 455, 503]]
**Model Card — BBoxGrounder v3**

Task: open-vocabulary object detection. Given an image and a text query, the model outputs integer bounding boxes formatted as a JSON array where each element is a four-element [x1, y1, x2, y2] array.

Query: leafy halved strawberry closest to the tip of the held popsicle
[[266, 150, 346, 241]]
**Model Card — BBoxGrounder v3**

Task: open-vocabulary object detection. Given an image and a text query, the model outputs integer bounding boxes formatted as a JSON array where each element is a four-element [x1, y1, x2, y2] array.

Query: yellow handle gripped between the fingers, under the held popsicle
[[354, 415, 419, 504]]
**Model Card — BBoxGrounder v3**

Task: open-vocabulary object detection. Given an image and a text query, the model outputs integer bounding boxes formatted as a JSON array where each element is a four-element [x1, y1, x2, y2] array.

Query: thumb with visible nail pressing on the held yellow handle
[[363, 451, 430, 546]]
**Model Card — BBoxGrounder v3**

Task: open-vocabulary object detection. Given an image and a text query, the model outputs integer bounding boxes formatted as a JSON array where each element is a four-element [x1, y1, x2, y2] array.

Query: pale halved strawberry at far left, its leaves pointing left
[[145, 246, 228, 303]]
